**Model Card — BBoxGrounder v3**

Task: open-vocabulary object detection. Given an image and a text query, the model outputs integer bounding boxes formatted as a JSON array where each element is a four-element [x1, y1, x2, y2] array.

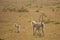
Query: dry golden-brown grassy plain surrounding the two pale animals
[[0, 0, 60, 40]]
